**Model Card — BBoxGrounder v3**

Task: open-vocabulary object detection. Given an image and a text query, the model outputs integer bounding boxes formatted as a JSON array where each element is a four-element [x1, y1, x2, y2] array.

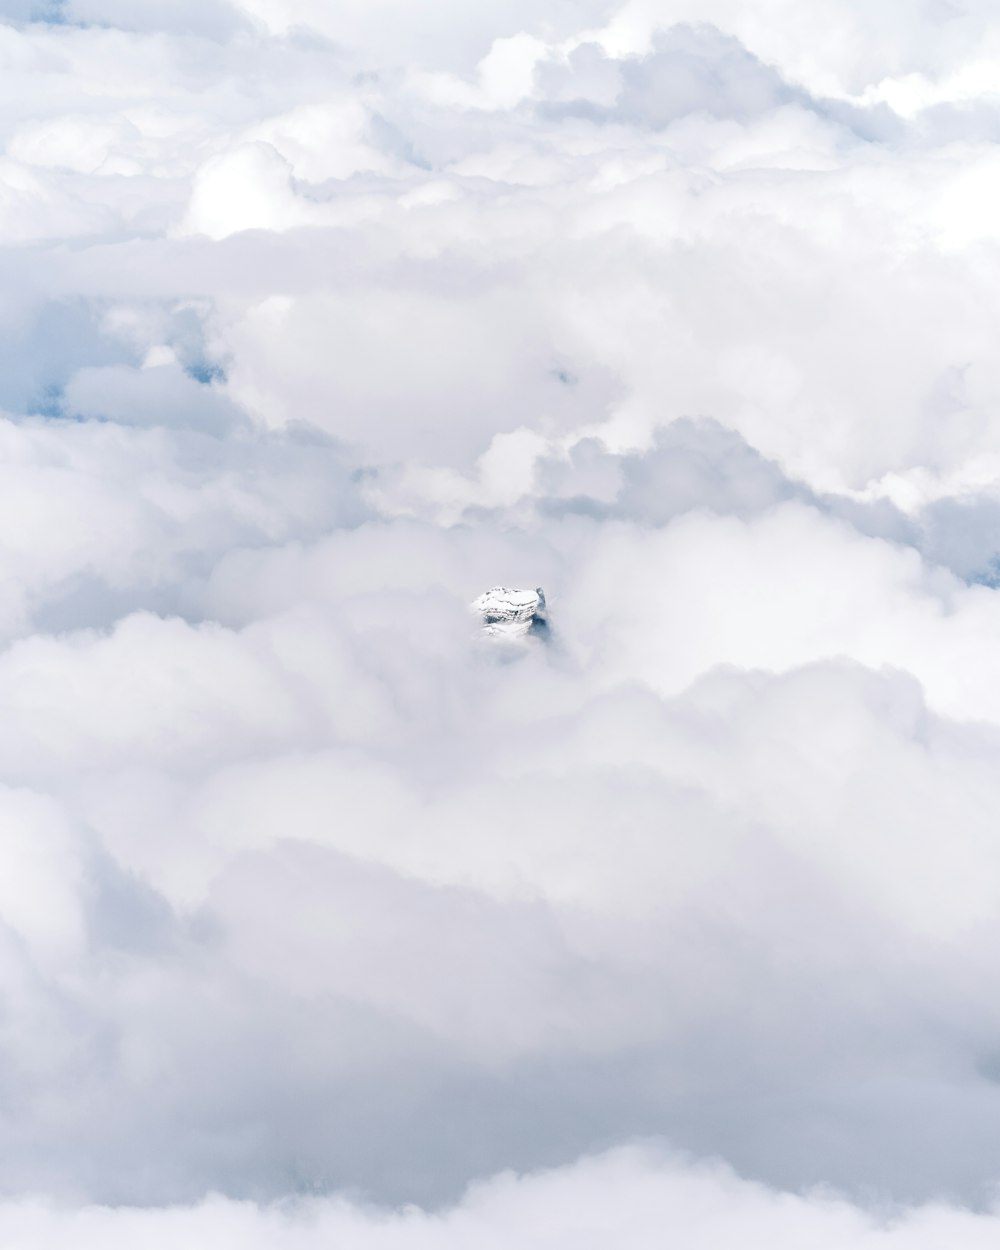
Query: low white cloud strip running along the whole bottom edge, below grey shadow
[[0, 1150, 998, 1250]]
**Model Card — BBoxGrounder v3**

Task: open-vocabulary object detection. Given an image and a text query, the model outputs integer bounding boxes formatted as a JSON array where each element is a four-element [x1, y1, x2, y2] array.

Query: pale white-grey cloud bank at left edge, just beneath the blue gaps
[[0, 417, 369, 639]]
